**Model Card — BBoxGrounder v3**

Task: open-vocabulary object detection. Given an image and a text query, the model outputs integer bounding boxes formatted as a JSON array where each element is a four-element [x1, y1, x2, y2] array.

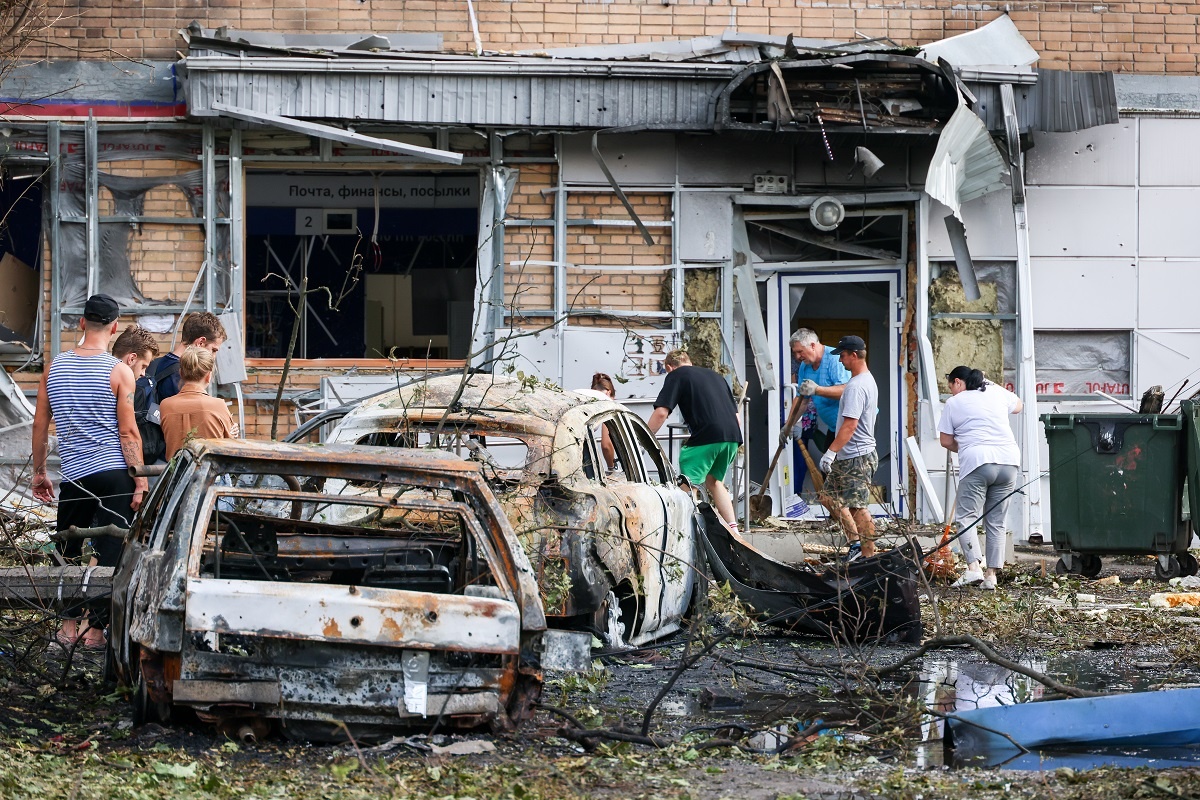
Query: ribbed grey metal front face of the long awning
[[185, 64, 728, 128]]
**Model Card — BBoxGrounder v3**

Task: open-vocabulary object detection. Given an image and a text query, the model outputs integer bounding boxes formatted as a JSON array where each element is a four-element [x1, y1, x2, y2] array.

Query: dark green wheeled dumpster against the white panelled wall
[[1040, 414, 1200, 581]]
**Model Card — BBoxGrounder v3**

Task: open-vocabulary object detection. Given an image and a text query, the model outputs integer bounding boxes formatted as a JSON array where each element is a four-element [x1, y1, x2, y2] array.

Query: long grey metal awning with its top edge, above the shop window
[[178, 55, 740, 131]]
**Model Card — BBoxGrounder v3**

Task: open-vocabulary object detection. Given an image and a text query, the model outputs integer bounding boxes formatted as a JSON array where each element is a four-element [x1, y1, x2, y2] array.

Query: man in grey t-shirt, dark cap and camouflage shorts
[[821, 336, 880, 560]]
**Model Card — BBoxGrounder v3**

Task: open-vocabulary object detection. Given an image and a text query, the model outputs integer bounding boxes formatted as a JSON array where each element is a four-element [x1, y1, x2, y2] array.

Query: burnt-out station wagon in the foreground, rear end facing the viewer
[[110, 440, 590, 739]]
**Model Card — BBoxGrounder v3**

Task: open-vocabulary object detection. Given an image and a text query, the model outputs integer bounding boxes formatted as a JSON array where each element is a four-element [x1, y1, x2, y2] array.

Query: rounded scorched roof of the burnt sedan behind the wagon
[[347, 374, 622, 435]]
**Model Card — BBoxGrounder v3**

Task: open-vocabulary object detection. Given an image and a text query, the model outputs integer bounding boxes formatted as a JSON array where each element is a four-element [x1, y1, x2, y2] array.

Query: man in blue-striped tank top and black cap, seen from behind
[[34, 294, 148, 642]]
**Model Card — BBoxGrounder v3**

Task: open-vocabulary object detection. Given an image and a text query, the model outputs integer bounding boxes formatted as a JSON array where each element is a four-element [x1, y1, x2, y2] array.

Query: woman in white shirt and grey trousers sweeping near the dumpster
[[937, 367, 1022, 590]]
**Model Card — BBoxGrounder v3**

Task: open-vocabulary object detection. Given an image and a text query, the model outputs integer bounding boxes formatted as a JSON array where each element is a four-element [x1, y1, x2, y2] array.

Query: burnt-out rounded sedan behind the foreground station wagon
[[329, 374, 700, 646]]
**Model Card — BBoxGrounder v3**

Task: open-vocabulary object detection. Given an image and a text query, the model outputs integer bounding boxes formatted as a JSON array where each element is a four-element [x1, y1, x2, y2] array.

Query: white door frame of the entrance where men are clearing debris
[[760, 261, 907, 519]]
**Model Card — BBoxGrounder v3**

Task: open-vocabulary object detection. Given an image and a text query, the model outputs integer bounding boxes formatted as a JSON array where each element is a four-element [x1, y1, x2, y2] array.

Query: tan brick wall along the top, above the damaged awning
[[28, 0, 1200, 73]]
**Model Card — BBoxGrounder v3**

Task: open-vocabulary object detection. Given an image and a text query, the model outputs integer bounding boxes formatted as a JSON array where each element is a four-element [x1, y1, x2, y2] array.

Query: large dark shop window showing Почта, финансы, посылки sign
[[246, 172, 479, 359]]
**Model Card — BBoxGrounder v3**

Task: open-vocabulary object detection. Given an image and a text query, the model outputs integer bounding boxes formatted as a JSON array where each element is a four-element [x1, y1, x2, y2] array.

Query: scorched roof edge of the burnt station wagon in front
[[185, 439, 479, 473]]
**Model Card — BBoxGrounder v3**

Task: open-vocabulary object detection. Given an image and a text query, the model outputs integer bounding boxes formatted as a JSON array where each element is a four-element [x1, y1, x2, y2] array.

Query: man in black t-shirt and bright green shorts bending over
[[648, 350, 742, 531]]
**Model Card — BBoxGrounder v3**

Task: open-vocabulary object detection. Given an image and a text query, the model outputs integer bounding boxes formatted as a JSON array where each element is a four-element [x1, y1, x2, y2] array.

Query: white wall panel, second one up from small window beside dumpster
[[1028, 186, 1138, 258]]
